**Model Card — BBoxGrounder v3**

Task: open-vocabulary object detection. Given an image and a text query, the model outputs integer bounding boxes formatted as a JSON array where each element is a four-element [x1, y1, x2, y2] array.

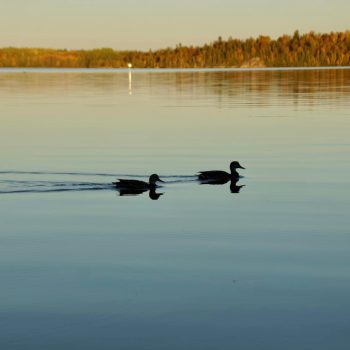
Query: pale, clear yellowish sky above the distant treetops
[[0, 0, 350, 50]]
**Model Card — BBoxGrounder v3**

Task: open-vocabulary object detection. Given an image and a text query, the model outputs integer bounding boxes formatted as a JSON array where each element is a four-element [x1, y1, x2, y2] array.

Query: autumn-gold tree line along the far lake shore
[[0, 31, 350, 68]]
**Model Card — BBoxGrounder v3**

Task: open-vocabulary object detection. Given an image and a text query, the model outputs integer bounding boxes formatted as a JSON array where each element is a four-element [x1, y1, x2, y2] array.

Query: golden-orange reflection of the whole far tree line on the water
[[0, 69, 350, 106]]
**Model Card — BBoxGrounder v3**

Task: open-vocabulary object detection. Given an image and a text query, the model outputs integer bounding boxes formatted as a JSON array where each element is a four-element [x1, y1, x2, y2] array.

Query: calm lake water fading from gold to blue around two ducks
[[0, 69, 350, 350]]
